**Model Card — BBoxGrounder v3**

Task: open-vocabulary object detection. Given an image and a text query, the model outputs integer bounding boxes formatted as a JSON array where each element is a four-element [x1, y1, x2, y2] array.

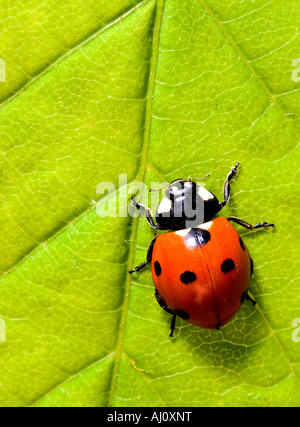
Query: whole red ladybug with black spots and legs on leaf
[[129, 163, 274, 337]]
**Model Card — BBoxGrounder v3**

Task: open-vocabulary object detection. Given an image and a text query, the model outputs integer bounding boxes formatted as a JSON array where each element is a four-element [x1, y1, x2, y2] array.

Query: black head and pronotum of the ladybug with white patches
[[156, 179, 221, 230]]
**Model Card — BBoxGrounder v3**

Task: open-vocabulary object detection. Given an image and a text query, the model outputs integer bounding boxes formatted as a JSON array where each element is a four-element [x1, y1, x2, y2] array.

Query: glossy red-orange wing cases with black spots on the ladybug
[[152, 217, 252, 329]]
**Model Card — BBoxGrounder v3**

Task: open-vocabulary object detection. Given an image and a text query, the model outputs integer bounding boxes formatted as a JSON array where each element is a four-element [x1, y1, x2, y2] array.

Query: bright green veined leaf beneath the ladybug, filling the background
[[0, 0, 300, 407]]
